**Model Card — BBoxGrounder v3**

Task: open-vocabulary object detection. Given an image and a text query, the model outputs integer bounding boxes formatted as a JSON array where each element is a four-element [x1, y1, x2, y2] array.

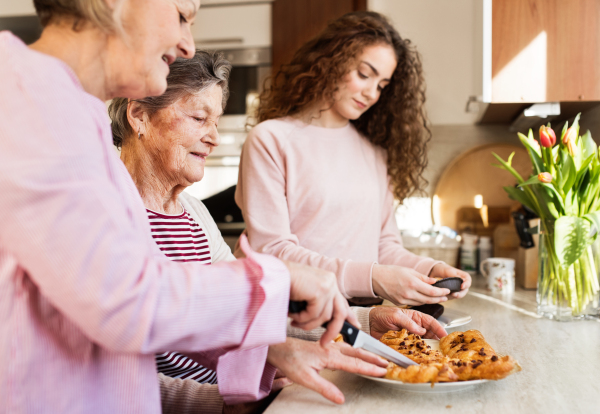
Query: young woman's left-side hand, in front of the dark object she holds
[[373, 264, 450, 305]]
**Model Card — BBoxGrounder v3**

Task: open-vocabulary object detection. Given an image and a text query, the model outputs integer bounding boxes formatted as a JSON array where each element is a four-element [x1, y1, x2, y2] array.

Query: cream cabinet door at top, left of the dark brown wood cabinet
[[192, 3, 271, 49]]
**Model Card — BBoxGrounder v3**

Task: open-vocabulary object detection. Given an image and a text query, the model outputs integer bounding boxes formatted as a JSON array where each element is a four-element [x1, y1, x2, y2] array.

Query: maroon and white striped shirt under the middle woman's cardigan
[[146, 206, 217, 384]]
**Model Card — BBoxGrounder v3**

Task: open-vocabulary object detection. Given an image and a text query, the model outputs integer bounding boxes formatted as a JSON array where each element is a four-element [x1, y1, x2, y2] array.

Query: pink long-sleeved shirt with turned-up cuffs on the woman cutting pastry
[[0, 32, 290, 414]]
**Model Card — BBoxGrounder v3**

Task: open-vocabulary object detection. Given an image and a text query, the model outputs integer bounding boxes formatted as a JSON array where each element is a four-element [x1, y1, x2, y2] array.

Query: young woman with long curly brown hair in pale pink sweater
[[236, 12, 471, 305]]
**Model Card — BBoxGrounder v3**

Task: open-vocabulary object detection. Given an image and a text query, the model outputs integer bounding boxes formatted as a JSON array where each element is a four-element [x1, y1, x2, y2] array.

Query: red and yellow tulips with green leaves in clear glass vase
[[494, 115, 600, 320]]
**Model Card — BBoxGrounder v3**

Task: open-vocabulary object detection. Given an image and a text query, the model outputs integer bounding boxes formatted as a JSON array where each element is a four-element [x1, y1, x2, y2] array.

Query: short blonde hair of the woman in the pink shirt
[[33, 0, 124, 32]]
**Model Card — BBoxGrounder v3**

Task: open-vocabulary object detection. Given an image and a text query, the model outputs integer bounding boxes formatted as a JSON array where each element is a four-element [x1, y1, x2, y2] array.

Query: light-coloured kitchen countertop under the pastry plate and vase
[[265, 277, 600, 414]]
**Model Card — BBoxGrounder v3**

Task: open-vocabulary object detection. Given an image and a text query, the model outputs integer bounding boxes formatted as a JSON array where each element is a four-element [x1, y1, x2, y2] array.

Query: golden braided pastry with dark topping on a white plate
[[361, 329, 521, 393]]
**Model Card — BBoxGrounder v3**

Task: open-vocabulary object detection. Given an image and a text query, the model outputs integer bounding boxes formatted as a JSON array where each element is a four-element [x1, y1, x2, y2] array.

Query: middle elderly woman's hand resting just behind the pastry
[[369, 306, 448, 339]]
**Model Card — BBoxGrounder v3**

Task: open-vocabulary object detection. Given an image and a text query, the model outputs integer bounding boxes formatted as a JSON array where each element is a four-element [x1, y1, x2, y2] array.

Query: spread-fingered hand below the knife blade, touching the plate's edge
[[267, 338, 388, 404]]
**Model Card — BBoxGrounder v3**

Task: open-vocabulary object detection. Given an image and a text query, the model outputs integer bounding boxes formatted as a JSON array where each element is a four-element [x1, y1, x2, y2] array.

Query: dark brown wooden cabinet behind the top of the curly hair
[[273, 0, 367, 72]]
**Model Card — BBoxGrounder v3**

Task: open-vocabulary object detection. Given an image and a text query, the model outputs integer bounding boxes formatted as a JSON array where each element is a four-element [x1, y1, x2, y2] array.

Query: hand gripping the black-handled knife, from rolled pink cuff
[[284, 261, 360, 345]]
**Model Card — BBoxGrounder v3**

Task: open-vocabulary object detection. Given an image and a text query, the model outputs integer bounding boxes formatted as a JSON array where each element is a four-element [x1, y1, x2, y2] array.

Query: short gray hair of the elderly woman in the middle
[[108, 50, 231, 148]]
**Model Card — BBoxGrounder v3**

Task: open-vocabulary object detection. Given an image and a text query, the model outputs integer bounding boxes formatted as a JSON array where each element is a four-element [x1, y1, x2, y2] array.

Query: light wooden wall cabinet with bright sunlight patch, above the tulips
[[484, 0, 600, 102]]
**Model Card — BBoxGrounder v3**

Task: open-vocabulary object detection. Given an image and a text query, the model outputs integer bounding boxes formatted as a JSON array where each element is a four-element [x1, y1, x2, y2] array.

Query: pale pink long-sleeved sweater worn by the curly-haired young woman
[[236, 118, 437, 298]]
